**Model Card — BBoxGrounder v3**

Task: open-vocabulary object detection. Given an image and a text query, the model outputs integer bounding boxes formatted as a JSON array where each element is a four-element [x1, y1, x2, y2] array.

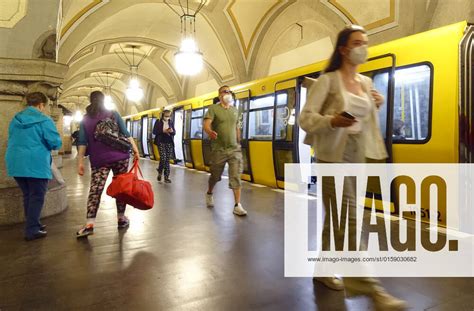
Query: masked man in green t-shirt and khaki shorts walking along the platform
[[204, 85, 247, 216]]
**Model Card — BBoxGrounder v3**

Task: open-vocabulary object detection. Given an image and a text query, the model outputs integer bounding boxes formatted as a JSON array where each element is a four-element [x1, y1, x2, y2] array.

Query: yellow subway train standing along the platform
[[124, 22, 474, 196]]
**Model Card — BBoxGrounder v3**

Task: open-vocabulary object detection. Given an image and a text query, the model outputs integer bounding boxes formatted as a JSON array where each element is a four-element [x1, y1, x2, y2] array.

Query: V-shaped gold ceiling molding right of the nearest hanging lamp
[[225, 0, 286, 59]]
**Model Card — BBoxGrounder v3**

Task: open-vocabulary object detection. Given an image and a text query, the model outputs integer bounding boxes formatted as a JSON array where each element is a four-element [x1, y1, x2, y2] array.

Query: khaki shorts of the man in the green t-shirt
[[209, 148, 243, 189]]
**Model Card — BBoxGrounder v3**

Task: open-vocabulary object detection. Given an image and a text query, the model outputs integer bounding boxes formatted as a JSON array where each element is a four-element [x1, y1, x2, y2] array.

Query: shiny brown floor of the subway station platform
[[0, 158, 474, 311]]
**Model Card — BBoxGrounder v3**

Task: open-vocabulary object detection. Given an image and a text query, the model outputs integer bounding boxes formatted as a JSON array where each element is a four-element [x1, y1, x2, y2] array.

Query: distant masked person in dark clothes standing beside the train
[[153, 110, 176, 183]]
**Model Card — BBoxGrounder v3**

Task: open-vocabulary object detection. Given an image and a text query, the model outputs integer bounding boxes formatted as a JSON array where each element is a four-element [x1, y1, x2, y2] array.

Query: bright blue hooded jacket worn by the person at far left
[[5, 107, 62, 179]]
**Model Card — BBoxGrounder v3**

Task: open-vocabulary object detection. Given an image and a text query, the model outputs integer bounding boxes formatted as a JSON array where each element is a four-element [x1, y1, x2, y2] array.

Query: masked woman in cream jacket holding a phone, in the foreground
[[299, 25, 407, 310]]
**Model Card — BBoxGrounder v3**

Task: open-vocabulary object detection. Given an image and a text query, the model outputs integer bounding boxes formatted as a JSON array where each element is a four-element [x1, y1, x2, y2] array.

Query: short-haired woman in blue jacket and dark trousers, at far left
[[5, 92, 62, 241]]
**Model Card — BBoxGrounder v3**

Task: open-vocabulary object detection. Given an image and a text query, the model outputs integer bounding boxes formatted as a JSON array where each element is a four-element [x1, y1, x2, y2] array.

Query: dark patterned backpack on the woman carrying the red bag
[[94, 116, 132, 152]]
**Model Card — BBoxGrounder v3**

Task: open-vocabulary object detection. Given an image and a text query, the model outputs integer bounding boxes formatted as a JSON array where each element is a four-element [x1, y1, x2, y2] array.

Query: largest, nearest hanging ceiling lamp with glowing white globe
[[163, 0, 207, 76]]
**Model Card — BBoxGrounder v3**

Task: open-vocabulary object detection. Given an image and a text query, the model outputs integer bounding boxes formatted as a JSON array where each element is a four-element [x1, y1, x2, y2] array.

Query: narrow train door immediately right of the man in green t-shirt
[[235, 90, 253, 181]]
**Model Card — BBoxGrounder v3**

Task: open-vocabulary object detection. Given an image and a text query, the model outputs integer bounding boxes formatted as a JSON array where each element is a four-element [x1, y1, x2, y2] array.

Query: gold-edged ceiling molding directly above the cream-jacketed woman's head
[[320, 0, 400, 34]]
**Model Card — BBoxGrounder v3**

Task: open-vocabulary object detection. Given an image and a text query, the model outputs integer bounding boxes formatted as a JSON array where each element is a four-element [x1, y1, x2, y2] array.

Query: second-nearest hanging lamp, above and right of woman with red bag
[[114, 44, 153, 102]]
